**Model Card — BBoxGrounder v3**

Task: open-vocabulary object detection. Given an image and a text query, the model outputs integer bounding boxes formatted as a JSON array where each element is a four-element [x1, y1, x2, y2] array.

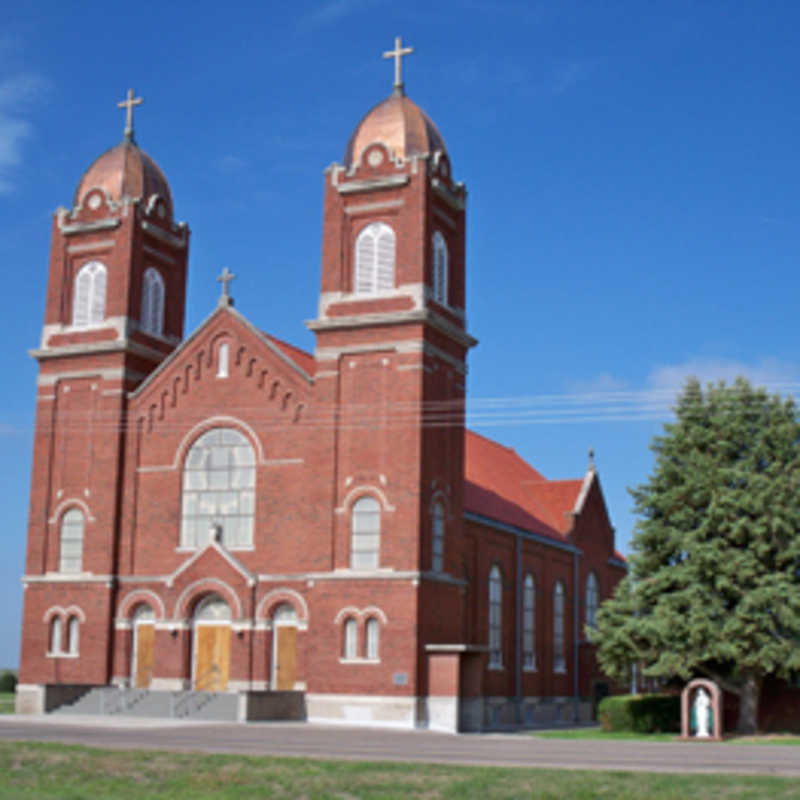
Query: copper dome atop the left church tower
[[73, 139, 172, 216]]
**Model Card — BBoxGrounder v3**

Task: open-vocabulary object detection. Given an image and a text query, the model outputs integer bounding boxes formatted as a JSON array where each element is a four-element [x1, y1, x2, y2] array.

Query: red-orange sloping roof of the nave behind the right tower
[[464, 430, 583, 541]]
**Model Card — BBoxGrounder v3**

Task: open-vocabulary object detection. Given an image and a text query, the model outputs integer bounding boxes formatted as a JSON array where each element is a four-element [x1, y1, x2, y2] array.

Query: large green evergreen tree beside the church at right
[[592, 378, 800, 732]]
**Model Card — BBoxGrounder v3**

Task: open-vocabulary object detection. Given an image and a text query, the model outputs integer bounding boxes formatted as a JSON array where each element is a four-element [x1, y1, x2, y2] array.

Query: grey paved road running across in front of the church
[[0, 715, 800, 778]]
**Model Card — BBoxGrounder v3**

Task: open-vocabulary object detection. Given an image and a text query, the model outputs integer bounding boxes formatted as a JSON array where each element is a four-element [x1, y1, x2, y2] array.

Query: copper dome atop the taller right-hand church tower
[[344, 93, 447, 167]]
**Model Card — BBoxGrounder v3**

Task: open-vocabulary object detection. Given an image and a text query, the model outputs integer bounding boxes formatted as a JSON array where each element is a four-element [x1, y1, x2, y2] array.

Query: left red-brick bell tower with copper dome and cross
[[21, 90, 189, 684]]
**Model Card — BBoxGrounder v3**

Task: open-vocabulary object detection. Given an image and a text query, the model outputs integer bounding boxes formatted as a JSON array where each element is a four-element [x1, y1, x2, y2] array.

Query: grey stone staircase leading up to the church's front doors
[[52, 686, 239, 722]]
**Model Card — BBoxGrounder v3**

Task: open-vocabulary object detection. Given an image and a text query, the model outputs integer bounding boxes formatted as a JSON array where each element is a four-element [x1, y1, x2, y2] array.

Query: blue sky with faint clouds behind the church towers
[[0, 0, 800, 666]]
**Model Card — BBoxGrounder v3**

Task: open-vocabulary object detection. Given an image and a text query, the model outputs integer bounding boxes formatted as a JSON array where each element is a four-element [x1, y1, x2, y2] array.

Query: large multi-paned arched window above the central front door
[[181, 428, 256, 548]]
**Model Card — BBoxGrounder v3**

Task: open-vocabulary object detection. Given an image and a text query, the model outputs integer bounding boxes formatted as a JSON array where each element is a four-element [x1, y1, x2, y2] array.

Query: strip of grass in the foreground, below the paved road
[[0, 742, 800, 800]]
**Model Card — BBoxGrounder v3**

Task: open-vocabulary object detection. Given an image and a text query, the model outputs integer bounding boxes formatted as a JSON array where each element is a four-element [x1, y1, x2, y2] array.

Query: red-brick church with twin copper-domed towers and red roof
[[12, 39, 626, 731]]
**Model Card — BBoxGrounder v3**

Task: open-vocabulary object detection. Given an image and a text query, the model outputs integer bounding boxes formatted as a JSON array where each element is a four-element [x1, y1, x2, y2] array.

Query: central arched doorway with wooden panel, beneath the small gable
[[192, 594, 231, 692]]
